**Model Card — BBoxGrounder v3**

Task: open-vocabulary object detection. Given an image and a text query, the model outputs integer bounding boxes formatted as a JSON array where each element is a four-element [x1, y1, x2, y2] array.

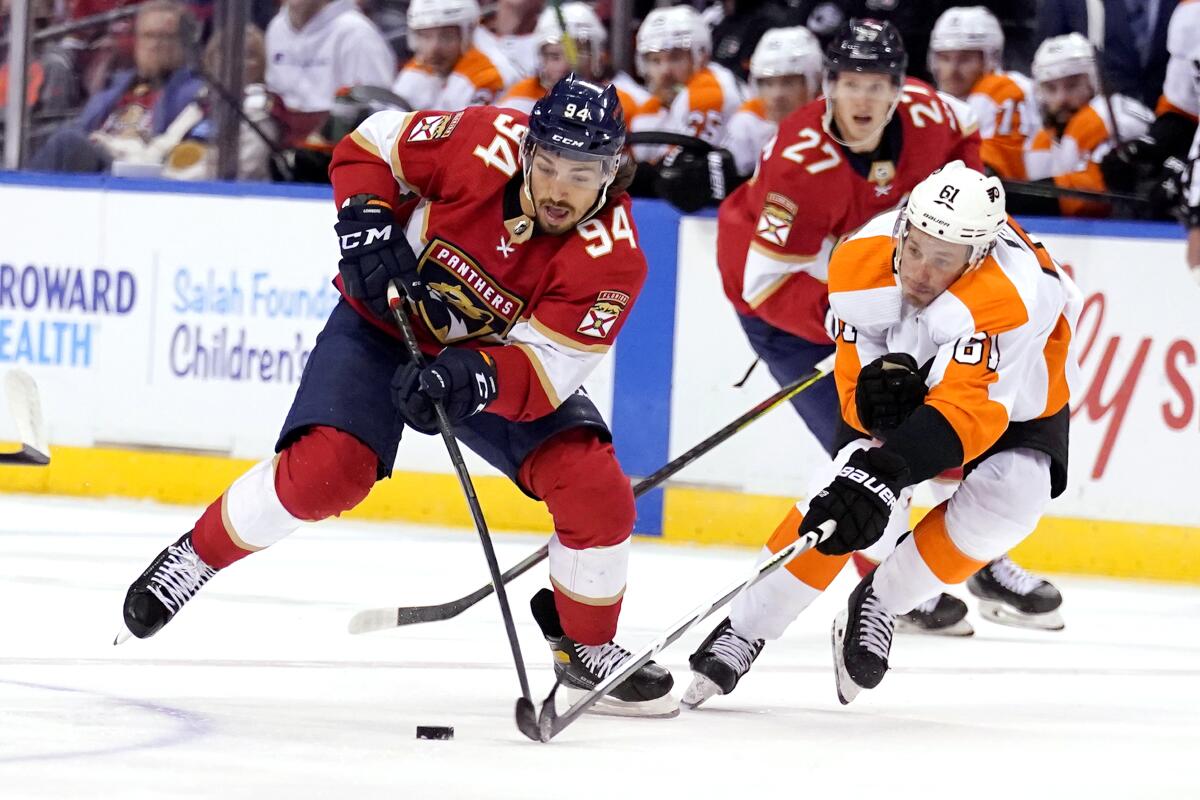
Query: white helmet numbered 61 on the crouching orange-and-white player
[[895, 161, 1008, 269]]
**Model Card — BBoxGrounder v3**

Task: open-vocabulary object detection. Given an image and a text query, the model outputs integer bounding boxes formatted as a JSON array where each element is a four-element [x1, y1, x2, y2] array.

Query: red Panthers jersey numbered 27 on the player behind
[[716, 78, 983, 342]]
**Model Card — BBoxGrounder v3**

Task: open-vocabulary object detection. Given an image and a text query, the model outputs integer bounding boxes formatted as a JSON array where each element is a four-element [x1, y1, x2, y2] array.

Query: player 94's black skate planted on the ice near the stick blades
[[529, 589, 679, 717]]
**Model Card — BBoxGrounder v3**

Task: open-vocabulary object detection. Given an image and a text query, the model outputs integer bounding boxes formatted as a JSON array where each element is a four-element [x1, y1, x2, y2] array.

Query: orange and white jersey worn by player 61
[[829, 210, 1082, 463]]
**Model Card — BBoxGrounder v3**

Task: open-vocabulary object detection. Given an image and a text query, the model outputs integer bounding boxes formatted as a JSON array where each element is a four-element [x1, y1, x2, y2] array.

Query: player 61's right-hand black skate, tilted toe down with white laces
[[833, 570, 895, 705]]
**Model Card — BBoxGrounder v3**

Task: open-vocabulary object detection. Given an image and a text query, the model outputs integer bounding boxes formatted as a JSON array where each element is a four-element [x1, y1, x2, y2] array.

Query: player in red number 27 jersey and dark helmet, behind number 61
[[716, 19, 983, 627]]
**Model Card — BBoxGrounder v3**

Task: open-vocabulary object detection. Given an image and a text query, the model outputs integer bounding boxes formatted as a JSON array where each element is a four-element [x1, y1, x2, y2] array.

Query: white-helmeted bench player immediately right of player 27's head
[[929, 6, 1042, 180]]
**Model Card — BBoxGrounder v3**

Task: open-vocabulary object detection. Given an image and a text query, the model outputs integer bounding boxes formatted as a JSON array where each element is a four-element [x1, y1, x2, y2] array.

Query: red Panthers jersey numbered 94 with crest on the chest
[[330, 107, 646, 421]]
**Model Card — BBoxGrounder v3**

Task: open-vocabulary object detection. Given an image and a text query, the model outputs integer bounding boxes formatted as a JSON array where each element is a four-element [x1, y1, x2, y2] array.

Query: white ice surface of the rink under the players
[[0, 495, 1200, 800]]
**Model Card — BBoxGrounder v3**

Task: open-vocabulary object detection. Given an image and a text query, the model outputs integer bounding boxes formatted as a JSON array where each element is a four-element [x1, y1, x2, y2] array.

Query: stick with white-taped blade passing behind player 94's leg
[[349, 356, 833, 633]]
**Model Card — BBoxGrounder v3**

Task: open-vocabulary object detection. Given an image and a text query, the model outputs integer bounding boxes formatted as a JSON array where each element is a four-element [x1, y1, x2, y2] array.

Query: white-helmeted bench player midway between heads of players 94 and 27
[[630, 6, 744, 152]]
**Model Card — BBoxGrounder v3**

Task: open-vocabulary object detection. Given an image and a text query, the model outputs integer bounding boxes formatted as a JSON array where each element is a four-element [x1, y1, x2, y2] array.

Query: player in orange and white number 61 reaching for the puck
[[684, 162, 1081, 706]]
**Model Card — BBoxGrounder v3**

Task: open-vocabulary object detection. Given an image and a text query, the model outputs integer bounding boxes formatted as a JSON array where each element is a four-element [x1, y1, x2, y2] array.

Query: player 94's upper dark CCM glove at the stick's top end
[[334, 204, 450, 333]]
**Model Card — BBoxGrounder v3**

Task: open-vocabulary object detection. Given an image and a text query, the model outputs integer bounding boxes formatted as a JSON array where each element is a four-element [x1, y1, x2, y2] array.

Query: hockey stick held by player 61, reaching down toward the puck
[[516, 519, 835, 742]]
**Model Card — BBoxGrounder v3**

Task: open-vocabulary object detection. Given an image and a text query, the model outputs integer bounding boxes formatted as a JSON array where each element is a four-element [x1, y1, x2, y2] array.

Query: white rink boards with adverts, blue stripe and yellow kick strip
[[0, 175, 1200, 582]]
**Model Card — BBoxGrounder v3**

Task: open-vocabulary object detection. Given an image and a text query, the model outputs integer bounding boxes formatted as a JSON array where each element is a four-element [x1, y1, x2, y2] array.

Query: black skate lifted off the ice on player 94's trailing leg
[[113, 533, 216, 644]]
